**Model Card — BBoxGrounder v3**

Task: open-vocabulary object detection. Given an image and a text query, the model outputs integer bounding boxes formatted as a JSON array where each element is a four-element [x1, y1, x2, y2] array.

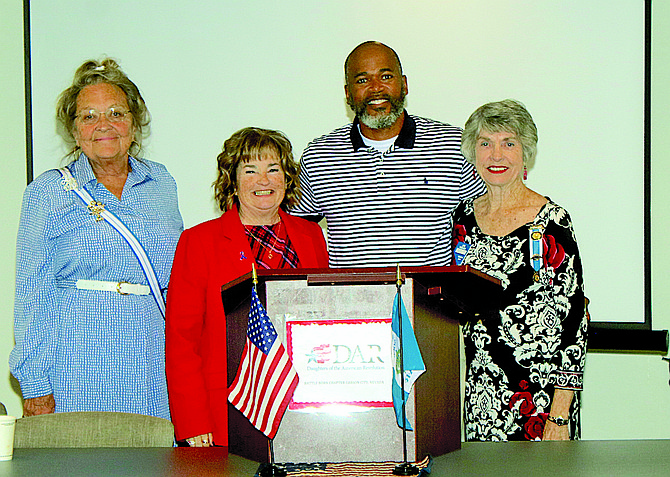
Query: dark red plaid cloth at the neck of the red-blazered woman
[[244, 222, 300, 270]]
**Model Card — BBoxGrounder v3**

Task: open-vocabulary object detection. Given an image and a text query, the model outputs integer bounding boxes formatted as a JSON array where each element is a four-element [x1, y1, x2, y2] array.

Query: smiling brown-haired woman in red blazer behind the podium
[[165, 128, 328, 447]]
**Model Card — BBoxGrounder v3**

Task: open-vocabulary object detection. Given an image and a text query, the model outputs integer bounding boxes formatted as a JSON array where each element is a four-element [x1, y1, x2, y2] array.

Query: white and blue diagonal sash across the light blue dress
[[58, 167, 165, 319]]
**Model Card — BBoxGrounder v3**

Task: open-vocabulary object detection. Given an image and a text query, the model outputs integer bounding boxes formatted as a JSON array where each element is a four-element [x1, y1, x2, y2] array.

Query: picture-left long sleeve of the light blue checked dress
[[9, 183, 59, 399]]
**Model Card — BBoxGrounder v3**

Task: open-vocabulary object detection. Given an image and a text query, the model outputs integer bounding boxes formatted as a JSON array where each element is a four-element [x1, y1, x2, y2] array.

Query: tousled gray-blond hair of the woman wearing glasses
[[56, 58, 151, 158]]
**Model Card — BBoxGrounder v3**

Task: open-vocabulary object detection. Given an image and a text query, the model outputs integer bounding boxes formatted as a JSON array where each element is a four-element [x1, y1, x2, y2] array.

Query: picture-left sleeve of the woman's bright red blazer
[[165, 230, 213, 439]]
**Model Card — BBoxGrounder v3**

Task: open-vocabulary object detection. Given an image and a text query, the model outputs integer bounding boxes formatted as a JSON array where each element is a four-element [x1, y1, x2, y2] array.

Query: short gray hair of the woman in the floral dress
[[461, 99, 537, 165]]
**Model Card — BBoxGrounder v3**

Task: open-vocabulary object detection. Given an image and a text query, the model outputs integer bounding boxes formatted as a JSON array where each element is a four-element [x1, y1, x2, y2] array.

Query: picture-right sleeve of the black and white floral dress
[[543, 208, 588, 391]]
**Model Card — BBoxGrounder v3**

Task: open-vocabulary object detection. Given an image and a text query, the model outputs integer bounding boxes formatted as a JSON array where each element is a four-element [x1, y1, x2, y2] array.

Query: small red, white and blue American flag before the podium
[[228, 287, 298, 439]]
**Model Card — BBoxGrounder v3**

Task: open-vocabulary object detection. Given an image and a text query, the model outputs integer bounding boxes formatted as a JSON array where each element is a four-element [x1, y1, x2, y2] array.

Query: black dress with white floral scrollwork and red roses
[[453, 199, 588, 441]]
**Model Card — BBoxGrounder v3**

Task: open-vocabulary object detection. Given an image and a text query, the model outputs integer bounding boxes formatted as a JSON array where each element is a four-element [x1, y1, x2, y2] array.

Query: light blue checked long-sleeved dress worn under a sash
[[9, 154, 183, 419]]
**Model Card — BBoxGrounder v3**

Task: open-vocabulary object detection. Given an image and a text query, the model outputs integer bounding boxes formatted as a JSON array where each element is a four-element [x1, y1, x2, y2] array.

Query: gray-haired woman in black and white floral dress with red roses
[[453, 100, 588, 441]]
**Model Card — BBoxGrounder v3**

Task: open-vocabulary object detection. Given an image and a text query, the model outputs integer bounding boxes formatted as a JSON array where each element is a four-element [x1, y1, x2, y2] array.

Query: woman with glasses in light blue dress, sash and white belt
[[10, 58, 183, 418]]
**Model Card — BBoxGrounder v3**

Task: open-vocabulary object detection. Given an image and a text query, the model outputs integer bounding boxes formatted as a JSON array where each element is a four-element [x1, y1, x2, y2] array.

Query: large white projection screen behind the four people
[[30, 0, 644, 322]]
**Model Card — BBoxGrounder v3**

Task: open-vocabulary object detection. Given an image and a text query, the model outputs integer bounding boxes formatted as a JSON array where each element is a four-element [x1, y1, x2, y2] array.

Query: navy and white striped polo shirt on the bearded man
[[291, 113, 485, 268]]
